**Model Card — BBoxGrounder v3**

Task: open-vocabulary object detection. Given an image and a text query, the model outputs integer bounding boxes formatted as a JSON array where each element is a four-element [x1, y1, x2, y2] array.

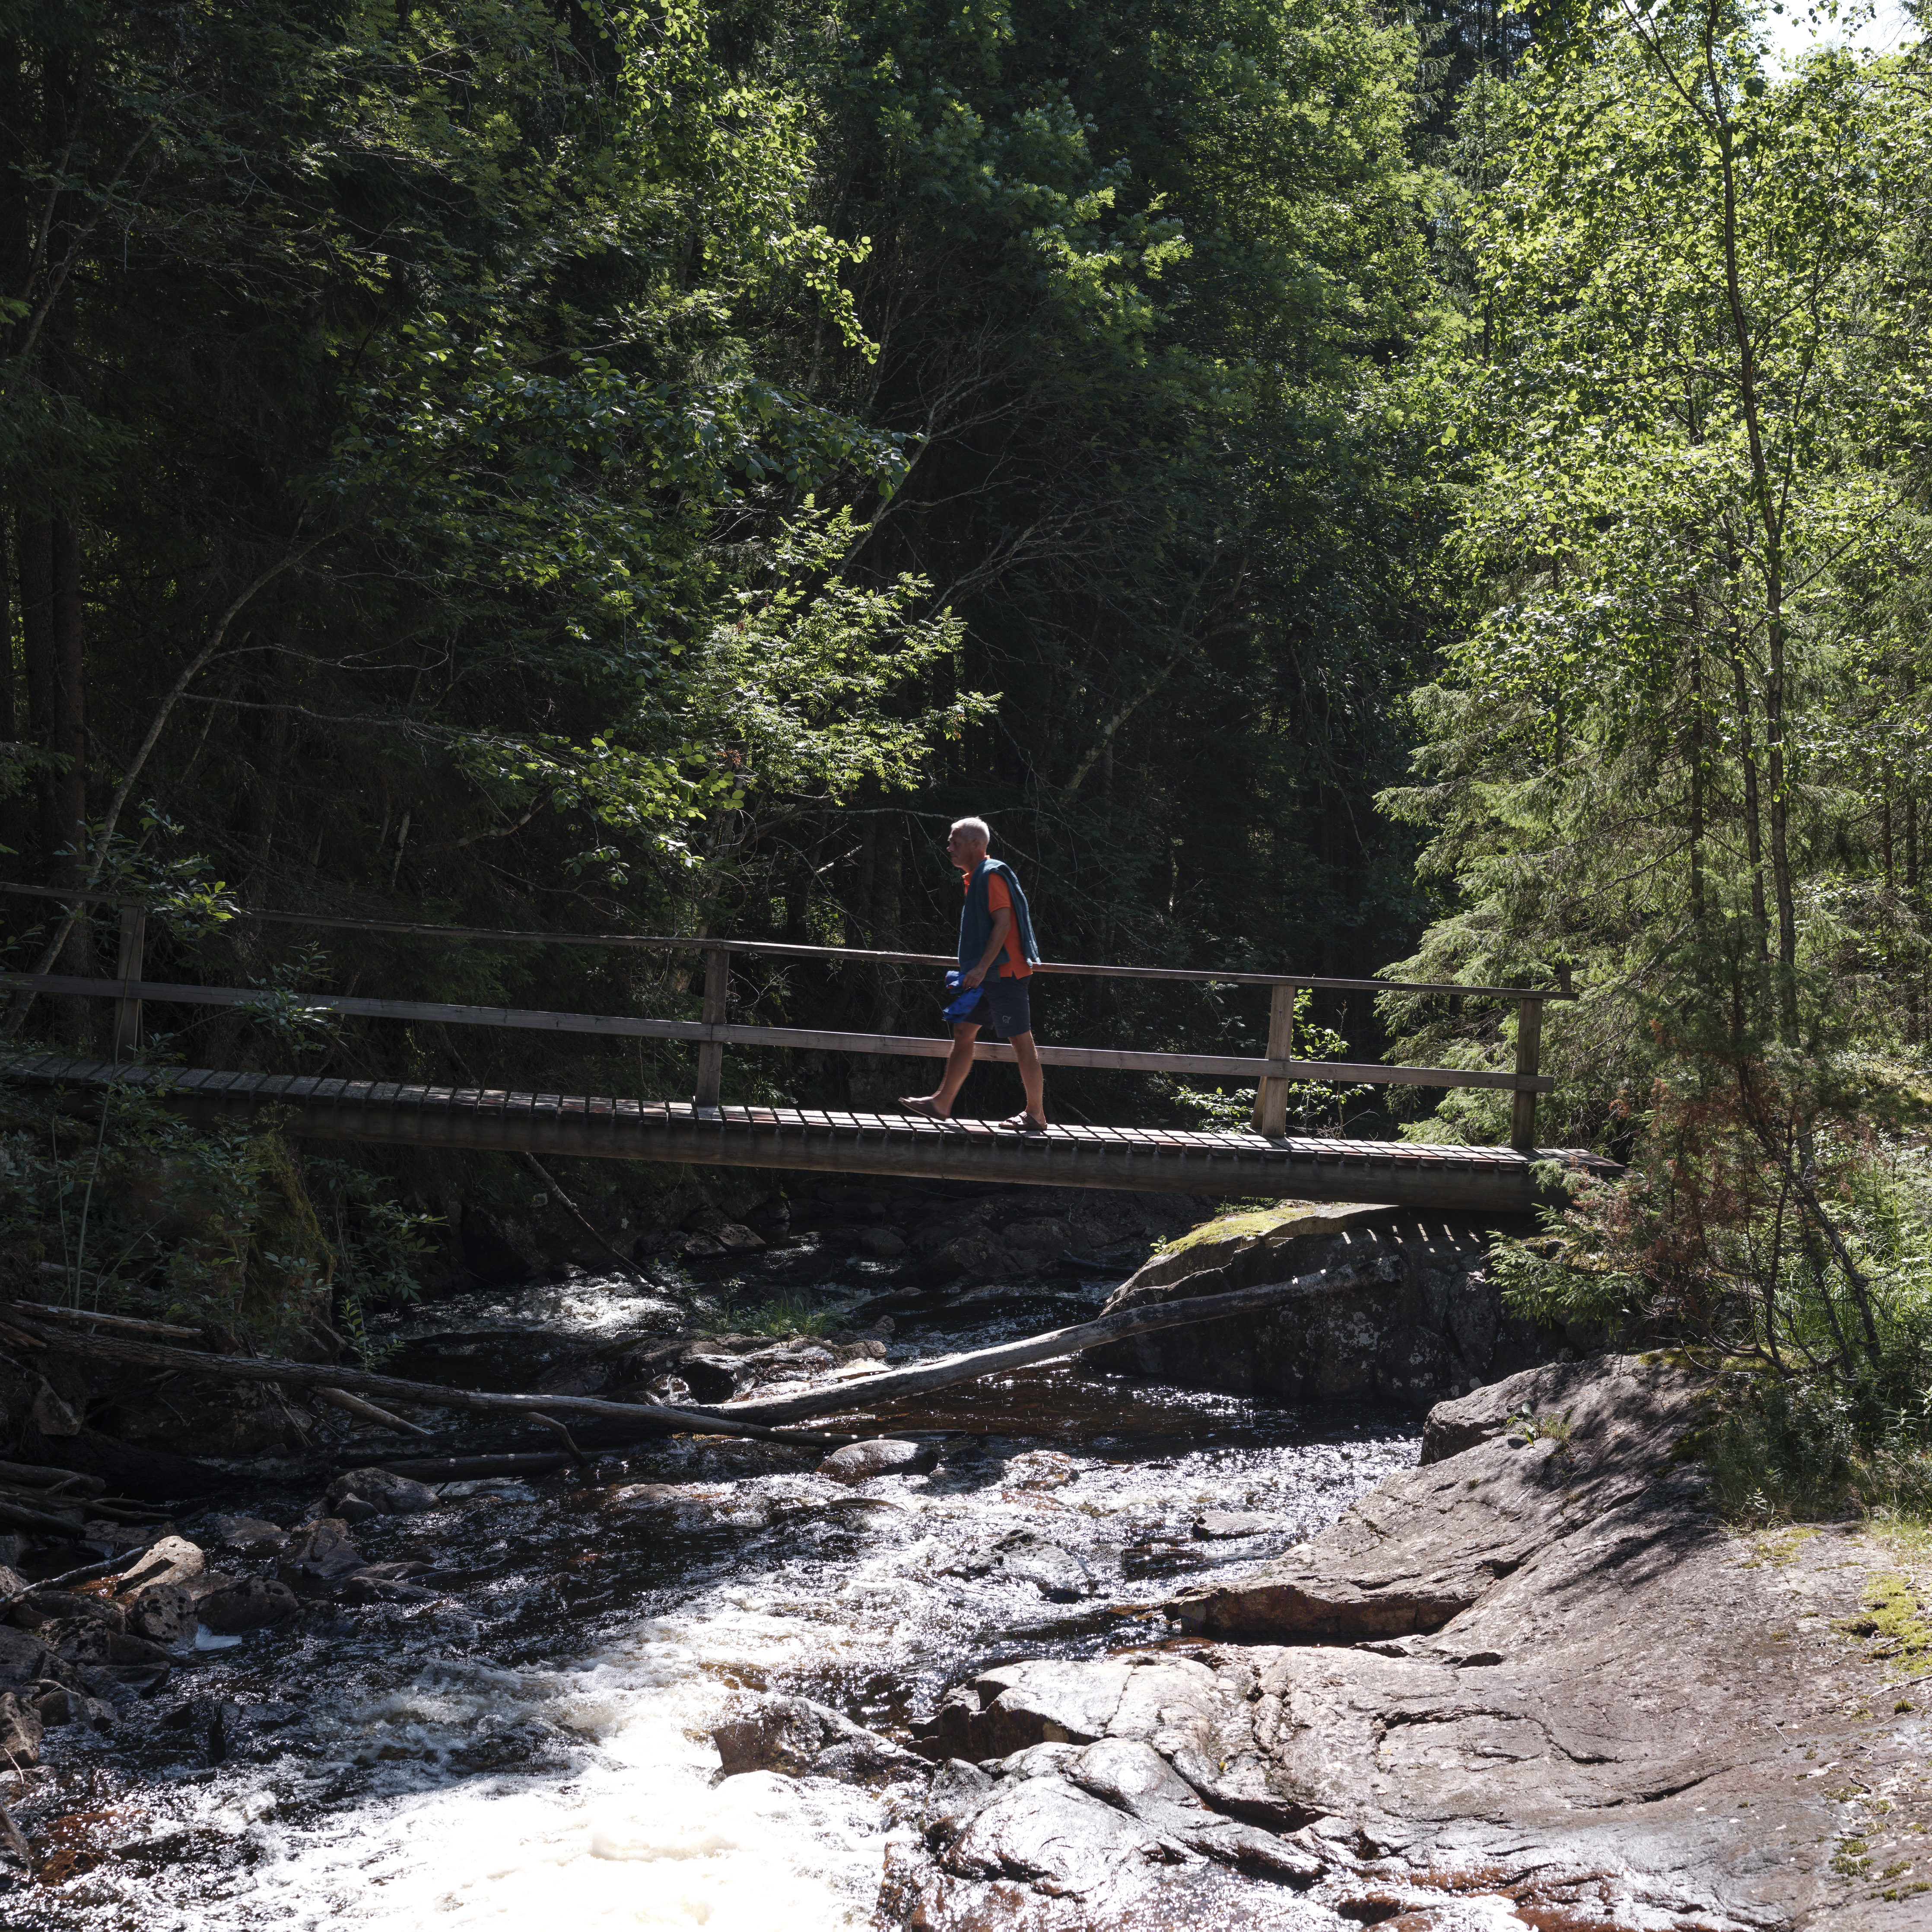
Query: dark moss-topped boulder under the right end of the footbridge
[[1088, 1204, 1590, 1408]]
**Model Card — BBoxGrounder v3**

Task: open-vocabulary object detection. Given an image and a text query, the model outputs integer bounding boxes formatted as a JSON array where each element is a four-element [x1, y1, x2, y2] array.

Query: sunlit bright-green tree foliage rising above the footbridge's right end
[[1383, 0, 1932, 1140]]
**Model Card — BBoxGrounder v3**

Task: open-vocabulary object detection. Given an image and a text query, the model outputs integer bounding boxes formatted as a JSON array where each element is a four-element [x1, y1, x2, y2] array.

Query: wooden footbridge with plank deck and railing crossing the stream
[[0, 885, 1608, 1213]]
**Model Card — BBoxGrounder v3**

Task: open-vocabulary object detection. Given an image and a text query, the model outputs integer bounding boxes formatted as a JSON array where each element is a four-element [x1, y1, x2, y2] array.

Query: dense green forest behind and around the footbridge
[[0, 0, 1932, 1493]]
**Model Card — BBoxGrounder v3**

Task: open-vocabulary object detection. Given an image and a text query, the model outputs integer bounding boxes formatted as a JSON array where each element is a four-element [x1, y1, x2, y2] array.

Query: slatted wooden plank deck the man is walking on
[[4, 1055, 1617, 1213]]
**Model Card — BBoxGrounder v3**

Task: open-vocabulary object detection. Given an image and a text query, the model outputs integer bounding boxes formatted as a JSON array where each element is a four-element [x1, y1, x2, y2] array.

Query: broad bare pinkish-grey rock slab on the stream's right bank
[[885, 1356, 1932, 1932]]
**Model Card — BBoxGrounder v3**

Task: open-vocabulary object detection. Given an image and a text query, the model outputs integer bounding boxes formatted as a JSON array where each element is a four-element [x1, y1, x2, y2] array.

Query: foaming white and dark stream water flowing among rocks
[[11, 1279, 1416, 1932]]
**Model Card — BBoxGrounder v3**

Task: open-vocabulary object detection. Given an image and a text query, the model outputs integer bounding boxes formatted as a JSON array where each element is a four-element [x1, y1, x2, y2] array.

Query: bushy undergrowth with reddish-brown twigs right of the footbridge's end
[[1495, 989, 1932, 1520]]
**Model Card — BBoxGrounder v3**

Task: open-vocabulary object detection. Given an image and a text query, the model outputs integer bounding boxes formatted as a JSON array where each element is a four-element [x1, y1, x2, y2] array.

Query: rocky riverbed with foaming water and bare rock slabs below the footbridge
[[0, 1198, 1932, 1932]]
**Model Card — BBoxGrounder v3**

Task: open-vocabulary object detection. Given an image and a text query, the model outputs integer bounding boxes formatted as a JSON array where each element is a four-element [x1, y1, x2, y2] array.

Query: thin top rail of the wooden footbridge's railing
[[0, 881, 1576, 1001]]
